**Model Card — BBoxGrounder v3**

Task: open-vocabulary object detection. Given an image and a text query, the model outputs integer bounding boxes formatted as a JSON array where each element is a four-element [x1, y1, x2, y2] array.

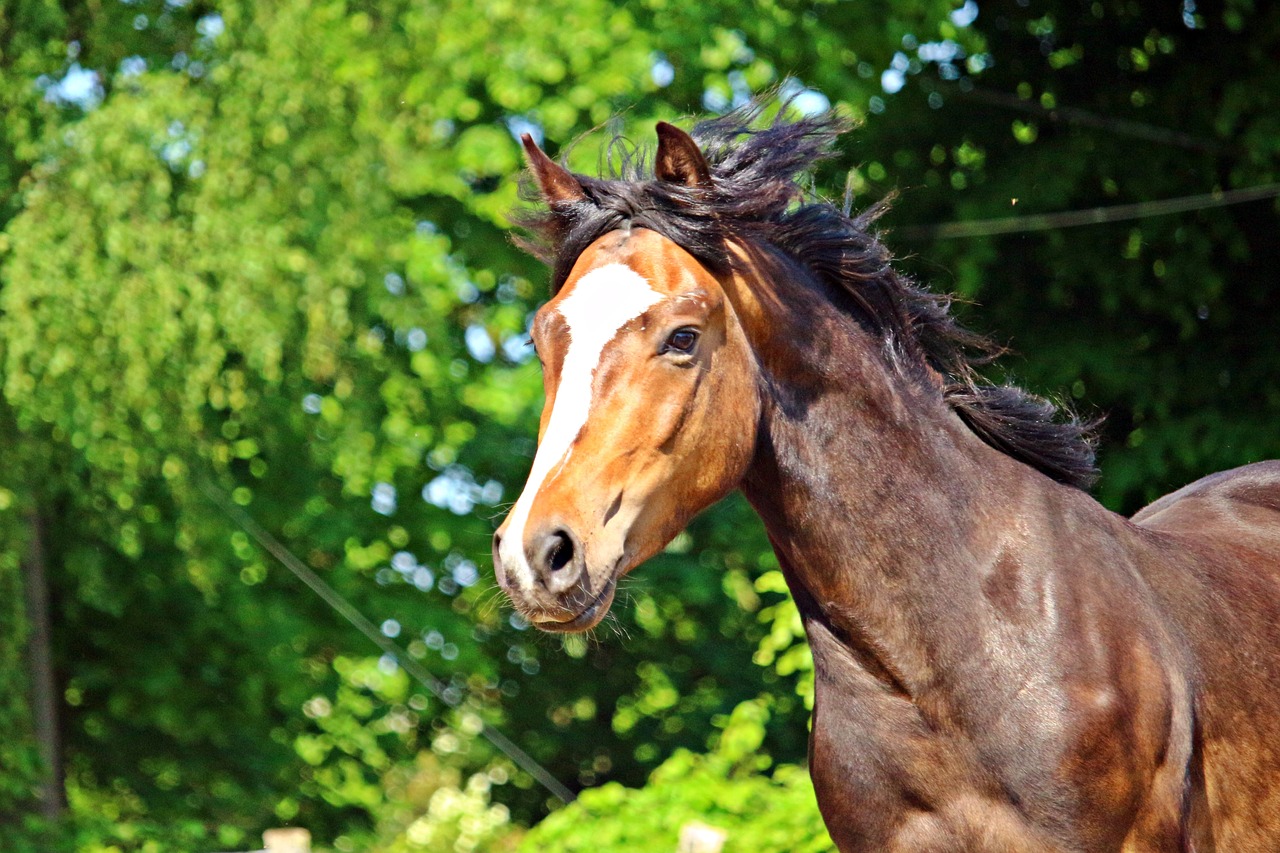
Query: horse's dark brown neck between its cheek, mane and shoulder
[[744, 266, 1123, 694]]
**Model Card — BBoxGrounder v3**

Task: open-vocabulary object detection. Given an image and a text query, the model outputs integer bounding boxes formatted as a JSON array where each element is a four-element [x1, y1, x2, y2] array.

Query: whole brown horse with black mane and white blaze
[[494, 108, 1280, 853]]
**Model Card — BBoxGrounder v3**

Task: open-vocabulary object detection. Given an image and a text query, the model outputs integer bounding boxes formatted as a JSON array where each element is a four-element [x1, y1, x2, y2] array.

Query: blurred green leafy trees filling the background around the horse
[[0, 0, 1280, 853]]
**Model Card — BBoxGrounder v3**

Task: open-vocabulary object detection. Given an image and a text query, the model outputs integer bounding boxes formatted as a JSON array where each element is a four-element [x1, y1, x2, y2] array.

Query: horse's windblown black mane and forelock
[[516, 104, 1097, 489]]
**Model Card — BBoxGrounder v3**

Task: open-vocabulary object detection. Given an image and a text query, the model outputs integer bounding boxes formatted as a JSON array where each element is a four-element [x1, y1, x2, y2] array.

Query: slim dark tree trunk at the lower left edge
[[22, 512, 67, 821]]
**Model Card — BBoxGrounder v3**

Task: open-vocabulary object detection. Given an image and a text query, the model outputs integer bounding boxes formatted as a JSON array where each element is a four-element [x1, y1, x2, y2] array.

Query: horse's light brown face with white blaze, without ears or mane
[[494, 229, 759, 631]]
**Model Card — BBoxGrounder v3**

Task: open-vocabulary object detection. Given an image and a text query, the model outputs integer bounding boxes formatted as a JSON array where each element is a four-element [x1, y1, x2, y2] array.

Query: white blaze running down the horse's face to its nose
[[498, 264, 662, 587]]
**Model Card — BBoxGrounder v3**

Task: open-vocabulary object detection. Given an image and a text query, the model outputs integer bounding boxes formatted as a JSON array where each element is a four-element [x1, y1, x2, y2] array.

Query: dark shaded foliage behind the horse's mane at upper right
[[869, 3, 1280, 512]]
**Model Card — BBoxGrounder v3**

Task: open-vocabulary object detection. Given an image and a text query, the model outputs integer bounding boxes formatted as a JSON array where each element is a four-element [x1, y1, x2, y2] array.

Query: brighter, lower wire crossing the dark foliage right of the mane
[[892, 183, 1280, 241]]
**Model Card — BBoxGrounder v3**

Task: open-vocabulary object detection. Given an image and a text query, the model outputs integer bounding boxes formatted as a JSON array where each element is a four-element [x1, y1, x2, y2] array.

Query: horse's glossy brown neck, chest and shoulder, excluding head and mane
[[733, 258, 1213, 850]]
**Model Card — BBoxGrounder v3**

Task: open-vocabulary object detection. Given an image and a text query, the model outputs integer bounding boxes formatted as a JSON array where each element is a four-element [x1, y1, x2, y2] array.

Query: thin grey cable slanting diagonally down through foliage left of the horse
[[201, 483, 575, 803]]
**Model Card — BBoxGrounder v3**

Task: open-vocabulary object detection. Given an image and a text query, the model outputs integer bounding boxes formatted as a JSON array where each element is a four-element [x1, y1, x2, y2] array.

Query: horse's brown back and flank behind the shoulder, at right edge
[[1133, 461, 1280, 853]]
